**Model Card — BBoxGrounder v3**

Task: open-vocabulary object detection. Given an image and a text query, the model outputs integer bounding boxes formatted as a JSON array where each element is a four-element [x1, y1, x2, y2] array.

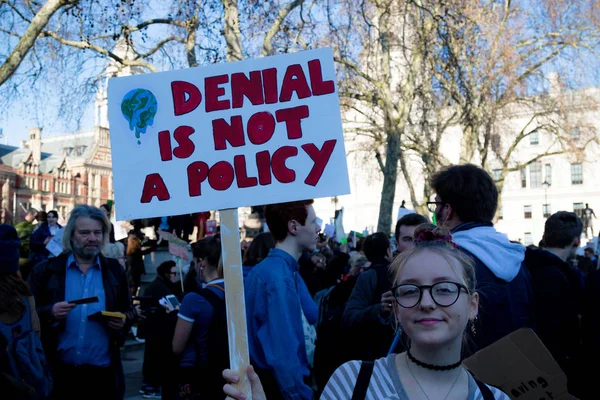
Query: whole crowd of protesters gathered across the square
[[0, 165, 600, 400]]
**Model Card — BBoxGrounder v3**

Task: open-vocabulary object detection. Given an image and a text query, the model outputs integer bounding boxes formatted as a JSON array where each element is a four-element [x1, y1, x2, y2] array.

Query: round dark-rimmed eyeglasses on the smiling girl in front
[[392, 281, 470, 308]]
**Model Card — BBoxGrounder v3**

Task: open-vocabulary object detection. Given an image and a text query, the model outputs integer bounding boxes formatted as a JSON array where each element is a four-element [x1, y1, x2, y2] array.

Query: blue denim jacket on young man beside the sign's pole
[[244, 249, 313, 400]]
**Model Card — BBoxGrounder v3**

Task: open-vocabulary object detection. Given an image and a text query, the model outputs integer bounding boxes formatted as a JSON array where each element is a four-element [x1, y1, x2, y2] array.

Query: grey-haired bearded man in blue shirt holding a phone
[[29, 205, 134, 400]]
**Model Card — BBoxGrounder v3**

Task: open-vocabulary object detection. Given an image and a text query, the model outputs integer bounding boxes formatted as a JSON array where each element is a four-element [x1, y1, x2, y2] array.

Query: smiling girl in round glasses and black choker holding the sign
[[223, 224, 509, 400]]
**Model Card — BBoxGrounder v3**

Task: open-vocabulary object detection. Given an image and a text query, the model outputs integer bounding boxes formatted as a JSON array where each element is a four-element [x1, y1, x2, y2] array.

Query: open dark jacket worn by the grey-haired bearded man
[[28, 252, 135, 398]]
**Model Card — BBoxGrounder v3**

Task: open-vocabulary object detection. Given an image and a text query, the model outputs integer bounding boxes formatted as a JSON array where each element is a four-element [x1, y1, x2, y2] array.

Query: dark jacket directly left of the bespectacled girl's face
[[342, 261, 394, 361]]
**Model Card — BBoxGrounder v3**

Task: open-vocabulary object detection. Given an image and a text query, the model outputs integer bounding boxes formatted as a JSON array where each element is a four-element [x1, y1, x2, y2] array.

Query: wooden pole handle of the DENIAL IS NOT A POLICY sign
[[219, 208, 252, 400]]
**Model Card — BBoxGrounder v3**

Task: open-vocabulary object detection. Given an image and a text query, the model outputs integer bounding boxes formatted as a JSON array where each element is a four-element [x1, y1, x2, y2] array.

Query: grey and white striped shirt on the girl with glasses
[[321, 354, 510, 400]]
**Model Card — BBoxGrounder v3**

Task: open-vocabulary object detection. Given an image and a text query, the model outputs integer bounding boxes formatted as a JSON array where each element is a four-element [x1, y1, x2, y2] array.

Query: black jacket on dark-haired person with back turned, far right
[[525, 249, 581, 381]]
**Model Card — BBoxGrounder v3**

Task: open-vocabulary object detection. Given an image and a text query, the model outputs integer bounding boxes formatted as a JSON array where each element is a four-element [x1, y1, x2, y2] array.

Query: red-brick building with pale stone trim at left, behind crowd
[[0, 126, 113, 223]]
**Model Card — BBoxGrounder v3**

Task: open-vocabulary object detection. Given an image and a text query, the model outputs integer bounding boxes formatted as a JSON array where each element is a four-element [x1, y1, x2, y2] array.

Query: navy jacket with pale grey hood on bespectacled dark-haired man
[[452, 223, 534, 356]]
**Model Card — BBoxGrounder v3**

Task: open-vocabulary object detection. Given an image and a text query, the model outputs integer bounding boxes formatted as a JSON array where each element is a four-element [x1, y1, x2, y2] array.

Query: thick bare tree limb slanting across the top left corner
[[0, 0, 77, 86]]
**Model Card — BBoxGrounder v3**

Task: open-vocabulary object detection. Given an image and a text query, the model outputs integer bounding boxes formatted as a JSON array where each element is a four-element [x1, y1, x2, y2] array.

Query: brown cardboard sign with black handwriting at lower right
[[463, 329, 577, 400]]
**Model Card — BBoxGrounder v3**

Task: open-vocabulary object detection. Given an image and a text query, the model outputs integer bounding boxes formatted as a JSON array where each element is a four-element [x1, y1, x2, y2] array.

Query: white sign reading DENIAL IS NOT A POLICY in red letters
[[108, 48, 350, 220]]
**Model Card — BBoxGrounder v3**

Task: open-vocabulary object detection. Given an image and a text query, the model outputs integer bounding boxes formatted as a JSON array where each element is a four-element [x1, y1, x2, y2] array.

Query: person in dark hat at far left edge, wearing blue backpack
[[0, 224, 40, 399]]
